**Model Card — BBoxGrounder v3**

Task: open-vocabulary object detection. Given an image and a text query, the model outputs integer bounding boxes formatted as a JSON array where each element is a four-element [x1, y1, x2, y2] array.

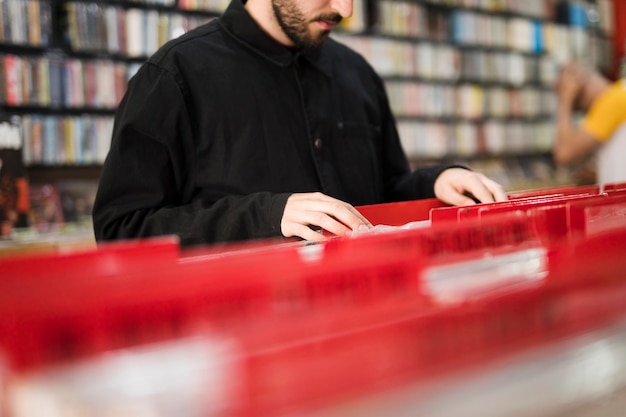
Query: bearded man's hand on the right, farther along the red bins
[[435, 168, 508, 206]]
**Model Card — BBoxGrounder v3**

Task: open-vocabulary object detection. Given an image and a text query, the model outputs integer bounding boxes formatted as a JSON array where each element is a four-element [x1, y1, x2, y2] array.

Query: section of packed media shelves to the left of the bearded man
[[0, 0, 217, 176]]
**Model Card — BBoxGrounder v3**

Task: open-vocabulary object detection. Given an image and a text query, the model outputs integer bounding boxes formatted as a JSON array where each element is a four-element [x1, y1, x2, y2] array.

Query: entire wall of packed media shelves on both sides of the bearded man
[[0, 0, 613, 226]]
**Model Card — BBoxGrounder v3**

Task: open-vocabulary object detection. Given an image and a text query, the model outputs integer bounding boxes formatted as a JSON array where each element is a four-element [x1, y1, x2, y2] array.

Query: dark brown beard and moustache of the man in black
[[272, 0, 341, 48]]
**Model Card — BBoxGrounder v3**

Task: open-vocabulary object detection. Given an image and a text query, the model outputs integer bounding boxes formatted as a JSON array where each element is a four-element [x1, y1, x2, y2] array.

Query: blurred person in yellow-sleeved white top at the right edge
[[553, 63, 626, 185]]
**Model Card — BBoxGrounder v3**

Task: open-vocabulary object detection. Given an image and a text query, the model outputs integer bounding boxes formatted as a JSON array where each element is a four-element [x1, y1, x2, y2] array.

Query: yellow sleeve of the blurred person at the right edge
[[582, 80, 626, 142]]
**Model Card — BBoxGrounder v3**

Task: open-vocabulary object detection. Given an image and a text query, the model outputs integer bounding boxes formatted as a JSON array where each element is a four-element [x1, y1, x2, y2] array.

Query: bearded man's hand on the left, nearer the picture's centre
[[280, 193, 372, 241]]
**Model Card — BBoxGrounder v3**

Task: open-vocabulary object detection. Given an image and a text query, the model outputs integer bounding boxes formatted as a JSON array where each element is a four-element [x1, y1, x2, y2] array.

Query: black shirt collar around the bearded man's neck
[[220, 0, 332, 77]]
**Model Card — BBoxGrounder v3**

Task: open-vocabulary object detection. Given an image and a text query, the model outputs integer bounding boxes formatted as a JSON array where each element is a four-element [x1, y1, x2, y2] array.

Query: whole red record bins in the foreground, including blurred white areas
[[0, 184, 626, 417]]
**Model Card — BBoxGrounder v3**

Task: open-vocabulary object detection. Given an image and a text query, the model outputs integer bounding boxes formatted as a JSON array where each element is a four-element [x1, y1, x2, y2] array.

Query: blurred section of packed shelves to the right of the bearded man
[[337, 0, 613, 189]]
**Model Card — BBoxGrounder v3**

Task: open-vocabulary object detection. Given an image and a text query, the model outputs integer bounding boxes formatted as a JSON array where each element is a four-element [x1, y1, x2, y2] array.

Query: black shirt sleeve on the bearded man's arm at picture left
[[93, 64, 289, 246]]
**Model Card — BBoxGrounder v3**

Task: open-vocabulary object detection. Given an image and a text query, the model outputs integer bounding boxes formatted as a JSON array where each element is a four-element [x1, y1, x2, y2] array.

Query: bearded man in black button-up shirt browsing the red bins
[[93, 0, 506, 245]]
